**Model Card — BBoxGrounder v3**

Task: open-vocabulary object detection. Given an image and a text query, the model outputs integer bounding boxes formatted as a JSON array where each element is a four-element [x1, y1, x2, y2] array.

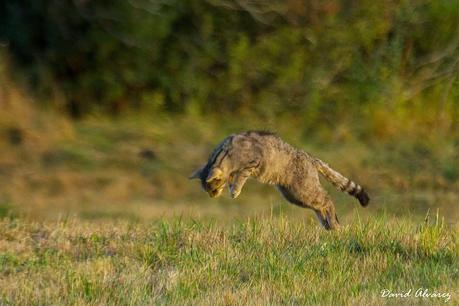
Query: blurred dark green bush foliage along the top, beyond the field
[[0, 0, 459, 133]]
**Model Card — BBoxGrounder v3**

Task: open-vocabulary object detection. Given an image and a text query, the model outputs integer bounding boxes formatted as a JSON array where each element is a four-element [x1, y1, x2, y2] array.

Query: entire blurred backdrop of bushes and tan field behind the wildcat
[[0, 0, 459, 224]]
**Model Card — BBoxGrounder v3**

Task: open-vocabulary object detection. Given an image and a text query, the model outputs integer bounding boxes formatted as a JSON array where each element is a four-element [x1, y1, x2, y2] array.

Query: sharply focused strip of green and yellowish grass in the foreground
[[0, 216, 459, 305]]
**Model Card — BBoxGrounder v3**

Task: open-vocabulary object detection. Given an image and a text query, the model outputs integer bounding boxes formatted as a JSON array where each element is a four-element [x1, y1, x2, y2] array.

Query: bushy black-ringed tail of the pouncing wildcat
[[314, 158, 370, 206]]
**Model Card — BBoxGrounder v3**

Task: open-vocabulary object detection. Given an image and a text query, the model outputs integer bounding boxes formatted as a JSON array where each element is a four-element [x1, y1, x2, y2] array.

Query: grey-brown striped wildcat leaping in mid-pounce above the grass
[[190, 131, 370, 229]]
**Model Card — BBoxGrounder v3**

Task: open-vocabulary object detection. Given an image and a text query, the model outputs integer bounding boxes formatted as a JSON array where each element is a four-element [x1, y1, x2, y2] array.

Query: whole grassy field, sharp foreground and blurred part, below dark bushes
[[0, 94, 459, 305]]
